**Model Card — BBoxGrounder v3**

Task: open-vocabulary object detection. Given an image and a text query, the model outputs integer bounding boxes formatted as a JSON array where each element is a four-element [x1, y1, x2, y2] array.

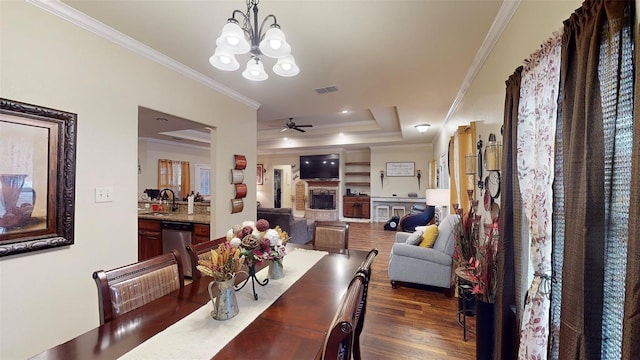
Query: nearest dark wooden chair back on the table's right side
[[322, 273, 366, 360]]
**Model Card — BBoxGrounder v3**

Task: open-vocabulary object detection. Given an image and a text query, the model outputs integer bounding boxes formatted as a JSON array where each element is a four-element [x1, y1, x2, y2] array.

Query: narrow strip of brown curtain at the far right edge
[[622, 20, 640, 360]]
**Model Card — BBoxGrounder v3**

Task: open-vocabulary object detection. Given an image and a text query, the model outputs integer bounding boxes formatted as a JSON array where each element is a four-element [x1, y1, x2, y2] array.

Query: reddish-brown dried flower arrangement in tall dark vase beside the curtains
[[467, 217, 500, 303]]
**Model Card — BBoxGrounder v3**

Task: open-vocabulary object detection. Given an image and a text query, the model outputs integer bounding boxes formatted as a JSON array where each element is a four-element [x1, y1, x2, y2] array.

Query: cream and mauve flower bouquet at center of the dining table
[[227, 219, 289, 266]]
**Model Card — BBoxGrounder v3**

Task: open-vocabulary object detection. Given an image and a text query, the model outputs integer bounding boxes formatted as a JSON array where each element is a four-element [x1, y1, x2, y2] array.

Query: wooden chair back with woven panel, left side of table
[[93, 250, 184, 325]]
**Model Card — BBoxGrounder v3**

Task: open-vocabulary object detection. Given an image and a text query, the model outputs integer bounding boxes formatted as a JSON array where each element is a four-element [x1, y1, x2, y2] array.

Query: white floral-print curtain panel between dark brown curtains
[[517, 34, 562, 359]]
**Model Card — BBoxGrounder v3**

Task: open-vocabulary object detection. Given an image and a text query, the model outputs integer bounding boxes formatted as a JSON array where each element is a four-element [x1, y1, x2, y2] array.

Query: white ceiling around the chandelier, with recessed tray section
[[56, 0, 519, 154]]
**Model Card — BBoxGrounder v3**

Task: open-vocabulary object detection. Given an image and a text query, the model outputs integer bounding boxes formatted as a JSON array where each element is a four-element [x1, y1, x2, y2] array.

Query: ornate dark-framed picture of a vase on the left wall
[[0, 98, 77, 256]]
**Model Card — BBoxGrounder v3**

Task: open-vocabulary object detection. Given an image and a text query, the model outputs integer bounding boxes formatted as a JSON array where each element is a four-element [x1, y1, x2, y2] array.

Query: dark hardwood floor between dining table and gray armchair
[[349, 222, 476, 360]]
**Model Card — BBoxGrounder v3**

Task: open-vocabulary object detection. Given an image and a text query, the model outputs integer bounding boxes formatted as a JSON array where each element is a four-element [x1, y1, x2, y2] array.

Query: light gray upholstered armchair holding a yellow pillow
[[388, 215, 460, 289]]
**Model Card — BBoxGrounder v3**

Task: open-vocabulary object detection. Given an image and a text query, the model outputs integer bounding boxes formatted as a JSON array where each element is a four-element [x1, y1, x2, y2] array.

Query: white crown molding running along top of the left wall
[[27, 0, 260, 110]]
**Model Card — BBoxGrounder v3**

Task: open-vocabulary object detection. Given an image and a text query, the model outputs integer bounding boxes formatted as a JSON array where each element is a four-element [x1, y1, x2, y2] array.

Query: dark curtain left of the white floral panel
[[494, 66, 522, 360]]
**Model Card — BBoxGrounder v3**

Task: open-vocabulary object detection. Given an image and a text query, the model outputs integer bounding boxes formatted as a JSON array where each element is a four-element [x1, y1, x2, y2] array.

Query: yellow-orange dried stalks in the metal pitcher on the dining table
[[196, 242, 244, 281]]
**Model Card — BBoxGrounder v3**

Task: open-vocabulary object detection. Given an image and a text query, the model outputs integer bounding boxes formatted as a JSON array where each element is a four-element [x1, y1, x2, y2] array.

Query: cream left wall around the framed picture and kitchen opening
[[0, 1, 256, 359]]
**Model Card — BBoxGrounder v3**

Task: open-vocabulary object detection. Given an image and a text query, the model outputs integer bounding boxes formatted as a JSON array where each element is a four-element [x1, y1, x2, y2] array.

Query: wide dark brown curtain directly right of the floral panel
[[559, 0, 637, 359]]
